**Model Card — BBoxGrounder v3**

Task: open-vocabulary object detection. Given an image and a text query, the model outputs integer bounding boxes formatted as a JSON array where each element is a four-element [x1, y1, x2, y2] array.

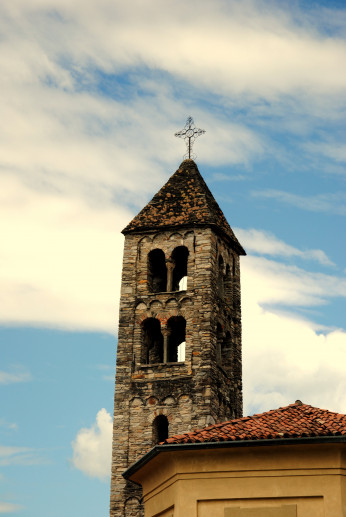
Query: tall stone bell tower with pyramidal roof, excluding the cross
[[110, 159, 245, 517]]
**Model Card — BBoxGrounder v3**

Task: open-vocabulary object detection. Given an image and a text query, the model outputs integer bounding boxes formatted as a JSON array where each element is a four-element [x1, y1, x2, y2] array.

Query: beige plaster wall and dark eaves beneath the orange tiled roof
[[132, 444, 346, 517]]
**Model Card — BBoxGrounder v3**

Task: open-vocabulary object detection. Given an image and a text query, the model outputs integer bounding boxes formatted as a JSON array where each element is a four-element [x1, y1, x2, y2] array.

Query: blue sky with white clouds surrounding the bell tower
[[0, 0, 346, 517]]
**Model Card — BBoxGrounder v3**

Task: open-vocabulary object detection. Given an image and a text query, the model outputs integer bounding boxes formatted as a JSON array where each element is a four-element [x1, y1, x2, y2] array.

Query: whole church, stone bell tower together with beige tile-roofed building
[[110, 123, 346, 517]]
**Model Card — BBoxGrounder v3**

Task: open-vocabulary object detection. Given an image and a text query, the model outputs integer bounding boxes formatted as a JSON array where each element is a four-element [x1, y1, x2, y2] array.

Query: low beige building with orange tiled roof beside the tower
[[125, 400, 346, 517]]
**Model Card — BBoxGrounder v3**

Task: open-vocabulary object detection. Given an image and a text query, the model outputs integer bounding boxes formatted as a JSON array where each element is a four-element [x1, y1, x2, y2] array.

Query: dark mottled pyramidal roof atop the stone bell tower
[[123, 160, 245, 255]]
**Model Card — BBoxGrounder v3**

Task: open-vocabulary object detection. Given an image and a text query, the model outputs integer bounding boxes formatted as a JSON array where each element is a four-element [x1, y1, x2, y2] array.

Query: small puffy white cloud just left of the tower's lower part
[[72, 409, 113, 480]]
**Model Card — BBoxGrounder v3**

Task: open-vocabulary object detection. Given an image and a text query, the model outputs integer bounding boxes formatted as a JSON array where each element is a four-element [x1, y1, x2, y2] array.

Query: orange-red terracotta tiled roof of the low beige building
[[162, 401, 346, 444]]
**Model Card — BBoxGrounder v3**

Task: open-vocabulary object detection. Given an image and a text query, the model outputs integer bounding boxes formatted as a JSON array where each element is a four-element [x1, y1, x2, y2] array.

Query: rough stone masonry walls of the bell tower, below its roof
[[110, 228, 242, 517]]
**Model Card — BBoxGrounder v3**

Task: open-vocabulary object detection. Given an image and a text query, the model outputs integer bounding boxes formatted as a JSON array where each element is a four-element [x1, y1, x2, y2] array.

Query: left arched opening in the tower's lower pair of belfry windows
[[141, 318, 163, 364]]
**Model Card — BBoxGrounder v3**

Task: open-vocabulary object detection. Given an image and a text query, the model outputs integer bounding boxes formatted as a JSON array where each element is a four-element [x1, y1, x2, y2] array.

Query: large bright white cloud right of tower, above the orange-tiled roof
[[242, 252, 346, 414]]
